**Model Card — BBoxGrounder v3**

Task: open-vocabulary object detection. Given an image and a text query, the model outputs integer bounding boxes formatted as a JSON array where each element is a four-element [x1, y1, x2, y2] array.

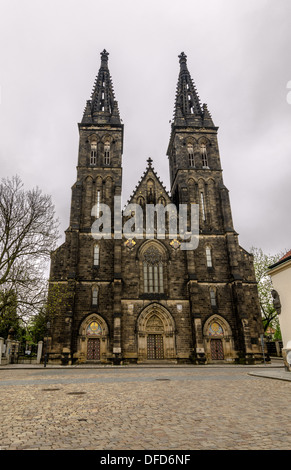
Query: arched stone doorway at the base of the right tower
[[203, 315, 236, 362]]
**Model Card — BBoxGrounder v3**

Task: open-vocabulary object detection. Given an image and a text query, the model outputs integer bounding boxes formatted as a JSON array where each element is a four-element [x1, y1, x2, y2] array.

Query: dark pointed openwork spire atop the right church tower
[[174, 52, 203, 126]]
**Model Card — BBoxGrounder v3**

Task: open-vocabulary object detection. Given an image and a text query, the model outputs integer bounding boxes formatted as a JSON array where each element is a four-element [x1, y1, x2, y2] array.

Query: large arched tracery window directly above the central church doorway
[[143, 246, 164, 294]]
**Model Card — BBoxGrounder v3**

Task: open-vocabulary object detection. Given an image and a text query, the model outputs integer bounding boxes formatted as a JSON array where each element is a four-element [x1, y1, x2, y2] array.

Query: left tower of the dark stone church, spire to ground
[[49, 50, 123, 361]]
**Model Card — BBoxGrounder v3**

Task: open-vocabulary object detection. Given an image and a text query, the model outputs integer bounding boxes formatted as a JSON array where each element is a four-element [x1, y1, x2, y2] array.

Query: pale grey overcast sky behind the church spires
[[0, 0, 291, 254]]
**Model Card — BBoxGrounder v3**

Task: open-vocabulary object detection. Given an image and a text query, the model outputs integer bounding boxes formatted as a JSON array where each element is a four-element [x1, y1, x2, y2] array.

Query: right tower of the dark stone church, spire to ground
[[167, 52, 261, 358]]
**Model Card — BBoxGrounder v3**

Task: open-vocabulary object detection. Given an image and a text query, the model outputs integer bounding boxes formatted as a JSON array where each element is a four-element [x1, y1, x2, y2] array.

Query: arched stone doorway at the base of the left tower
[[77, 313, 108, 362]]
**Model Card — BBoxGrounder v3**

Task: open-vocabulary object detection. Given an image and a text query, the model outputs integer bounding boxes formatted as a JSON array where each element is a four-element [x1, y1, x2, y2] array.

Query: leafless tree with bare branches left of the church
[[0, 176, 59, 324]]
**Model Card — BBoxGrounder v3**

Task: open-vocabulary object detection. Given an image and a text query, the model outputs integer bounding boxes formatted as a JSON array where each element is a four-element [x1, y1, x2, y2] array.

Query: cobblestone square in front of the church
[[0, 366, 291, 451]]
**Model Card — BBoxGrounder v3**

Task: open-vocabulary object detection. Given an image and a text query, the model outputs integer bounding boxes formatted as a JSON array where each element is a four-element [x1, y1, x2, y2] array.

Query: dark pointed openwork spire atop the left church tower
[[82, 49, 121, 124]]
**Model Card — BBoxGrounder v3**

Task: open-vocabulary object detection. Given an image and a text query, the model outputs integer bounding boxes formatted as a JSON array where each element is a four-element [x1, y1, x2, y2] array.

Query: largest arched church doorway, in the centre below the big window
[[137, 304, 176, 362]]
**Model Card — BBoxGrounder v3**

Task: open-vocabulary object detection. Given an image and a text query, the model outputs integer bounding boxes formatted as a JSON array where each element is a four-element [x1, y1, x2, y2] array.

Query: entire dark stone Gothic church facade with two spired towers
[[48, 50, 263, 364]]
